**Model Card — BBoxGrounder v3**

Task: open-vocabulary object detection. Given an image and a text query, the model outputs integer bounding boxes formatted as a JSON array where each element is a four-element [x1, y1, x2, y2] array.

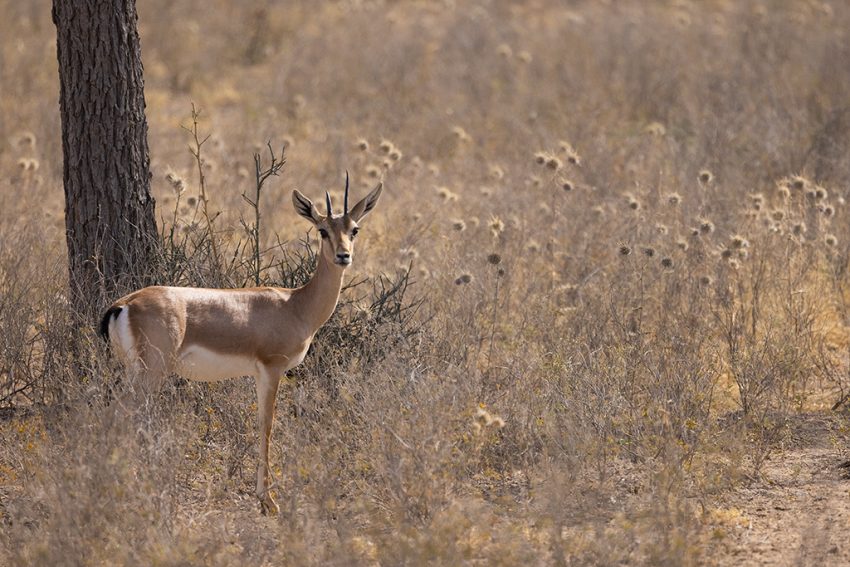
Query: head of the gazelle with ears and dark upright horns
[[292, 171, 383, 268]]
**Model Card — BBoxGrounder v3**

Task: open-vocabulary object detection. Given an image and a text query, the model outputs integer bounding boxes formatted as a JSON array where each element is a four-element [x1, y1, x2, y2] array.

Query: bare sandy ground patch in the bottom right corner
[[706, 413, 850, 566]]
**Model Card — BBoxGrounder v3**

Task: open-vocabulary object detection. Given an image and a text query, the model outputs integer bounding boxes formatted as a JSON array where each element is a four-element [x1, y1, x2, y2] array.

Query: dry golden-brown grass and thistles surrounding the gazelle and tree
[[0, 0, 850, 565]]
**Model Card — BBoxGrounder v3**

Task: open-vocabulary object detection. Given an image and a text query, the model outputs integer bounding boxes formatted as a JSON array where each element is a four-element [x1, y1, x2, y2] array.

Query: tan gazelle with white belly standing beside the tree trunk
[[100, 173, 382, 514]]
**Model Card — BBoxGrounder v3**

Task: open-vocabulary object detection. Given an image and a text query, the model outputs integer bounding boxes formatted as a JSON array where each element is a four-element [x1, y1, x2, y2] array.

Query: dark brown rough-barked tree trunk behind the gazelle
[[53, 0, 159, 317]]
